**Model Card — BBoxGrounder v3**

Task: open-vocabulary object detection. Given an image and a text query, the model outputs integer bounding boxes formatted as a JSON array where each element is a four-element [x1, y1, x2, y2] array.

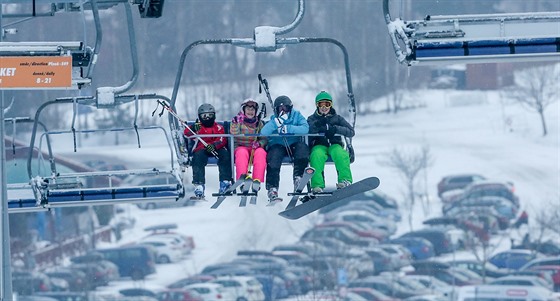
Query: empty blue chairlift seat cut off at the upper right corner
[[383, 0, 560, 66]]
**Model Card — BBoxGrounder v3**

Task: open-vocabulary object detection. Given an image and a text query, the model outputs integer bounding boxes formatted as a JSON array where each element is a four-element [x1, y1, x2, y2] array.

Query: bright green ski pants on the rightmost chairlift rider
[[309, 144, 352, 188]]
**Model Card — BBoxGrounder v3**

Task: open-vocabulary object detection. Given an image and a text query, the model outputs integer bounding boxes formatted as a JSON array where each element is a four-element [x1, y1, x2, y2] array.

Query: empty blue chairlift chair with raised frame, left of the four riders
[[9, 95, 184, 212]]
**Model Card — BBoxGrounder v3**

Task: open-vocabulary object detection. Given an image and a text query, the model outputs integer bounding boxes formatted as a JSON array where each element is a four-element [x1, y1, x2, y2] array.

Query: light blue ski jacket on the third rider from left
[[261, 109, 309, 146]]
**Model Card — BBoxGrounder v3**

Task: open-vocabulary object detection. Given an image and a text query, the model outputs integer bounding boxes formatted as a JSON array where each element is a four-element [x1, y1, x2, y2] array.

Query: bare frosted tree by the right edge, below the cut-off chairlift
[[505, 64, 560, 136]]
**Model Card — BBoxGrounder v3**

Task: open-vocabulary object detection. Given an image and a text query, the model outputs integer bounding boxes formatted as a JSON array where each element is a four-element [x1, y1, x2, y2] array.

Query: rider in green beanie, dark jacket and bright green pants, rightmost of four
[[307, 91, 354, 193]]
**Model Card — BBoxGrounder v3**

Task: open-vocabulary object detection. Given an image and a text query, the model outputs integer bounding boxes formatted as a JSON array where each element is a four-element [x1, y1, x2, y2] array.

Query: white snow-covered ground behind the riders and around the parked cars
[[59, 86, 560, 291]]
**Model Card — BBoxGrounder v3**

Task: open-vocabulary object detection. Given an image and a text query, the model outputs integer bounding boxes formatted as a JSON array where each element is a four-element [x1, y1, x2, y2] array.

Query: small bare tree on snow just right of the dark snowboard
[[379, 145, 433, 229]]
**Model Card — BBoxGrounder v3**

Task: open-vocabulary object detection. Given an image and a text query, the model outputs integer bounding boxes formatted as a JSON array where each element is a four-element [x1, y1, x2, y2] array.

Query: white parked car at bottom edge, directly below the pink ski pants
[[212, 276, 265, 301]]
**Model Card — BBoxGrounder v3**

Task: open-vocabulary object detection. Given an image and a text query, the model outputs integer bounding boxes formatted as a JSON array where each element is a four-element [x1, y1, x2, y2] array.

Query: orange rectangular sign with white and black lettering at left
[[0, 56, 72, 90]]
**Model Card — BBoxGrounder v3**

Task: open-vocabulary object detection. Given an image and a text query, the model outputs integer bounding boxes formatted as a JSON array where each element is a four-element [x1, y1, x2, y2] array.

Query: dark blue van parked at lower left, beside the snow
[[96, 245, 156, 280]]
